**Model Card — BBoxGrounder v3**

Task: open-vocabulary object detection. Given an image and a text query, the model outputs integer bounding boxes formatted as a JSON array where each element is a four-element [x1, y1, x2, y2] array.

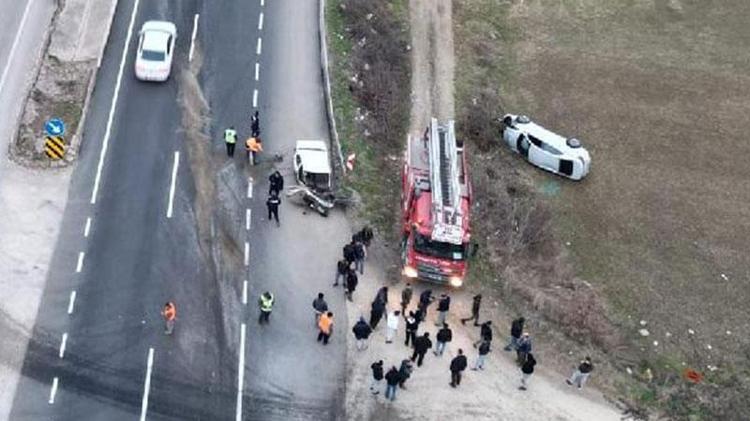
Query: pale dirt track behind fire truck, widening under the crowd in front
[[328, 0, 619, 420]]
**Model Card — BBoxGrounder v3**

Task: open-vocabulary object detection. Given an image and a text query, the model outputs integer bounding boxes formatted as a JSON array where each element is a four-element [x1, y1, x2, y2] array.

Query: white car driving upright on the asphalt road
[[135, 20, 177, 82]]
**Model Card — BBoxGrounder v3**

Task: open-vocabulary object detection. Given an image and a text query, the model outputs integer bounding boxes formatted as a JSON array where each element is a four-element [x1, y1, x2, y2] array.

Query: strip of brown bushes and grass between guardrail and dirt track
[[330, 0, 411, 244]]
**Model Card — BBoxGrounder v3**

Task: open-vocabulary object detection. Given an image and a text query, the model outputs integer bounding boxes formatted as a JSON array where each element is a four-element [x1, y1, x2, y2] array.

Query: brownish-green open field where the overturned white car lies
[[454, 0, 750, 419]]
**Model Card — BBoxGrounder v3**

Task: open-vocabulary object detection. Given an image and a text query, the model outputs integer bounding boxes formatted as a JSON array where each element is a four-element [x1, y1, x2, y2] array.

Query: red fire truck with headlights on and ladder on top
[[401, 118, 471, 287]]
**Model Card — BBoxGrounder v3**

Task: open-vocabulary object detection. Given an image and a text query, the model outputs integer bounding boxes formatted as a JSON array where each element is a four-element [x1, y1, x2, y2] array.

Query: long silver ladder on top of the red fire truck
[[429, 118, 462, 244]]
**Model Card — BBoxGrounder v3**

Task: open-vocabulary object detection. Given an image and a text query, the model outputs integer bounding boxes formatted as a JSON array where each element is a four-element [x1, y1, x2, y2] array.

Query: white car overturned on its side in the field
[[503, 114, 591, 180]]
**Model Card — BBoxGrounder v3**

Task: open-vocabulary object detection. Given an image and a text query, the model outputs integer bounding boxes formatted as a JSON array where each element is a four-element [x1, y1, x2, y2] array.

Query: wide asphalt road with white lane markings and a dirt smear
[[11, 0, 349, 420]]
